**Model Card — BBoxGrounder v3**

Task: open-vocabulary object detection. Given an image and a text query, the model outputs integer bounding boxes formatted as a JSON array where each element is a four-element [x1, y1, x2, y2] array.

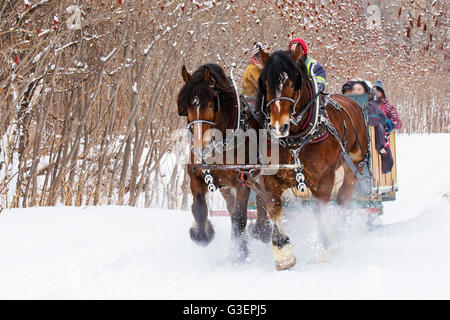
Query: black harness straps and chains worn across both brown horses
[[187, 71, 371, 192]]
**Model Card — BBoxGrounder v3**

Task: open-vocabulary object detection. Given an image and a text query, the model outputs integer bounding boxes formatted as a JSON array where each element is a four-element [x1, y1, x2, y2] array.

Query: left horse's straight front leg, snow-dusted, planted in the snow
[[231, 185, 250, 261]]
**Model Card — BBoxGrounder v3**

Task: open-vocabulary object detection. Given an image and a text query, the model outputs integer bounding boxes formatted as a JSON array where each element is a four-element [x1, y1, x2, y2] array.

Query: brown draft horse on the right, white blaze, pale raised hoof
[[258, 46, 368, 270]]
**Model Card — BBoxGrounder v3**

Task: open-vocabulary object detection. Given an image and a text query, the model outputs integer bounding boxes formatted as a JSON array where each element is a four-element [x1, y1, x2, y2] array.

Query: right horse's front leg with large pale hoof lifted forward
[[264, 176, 296, 271]]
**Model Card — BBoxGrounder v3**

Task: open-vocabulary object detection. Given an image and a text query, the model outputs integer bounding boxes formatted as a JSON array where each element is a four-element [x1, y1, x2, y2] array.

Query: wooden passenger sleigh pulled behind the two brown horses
[[210, 94, 398, 221]]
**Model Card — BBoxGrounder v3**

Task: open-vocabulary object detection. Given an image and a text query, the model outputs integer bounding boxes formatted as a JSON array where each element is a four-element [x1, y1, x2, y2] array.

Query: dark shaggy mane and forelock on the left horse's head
[[177, 64, 237, 116]]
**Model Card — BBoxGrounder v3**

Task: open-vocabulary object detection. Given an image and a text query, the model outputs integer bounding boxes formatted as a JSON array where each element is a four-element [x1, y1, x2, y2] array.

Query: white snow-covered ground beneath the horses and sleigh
[[0, 134, 450, 299]]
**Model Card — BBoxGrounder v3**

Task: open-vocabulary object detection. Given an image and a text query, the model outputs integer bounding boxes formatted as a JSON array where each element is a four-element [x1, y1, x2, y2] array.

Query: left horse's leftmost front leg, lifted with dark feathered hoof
[[189, 177, 214, 246]]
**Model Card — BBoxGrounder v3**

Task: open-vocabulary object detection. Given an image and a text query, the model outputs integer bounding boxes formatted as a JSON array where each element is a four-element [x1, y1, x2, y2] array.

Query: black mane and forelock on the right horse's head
[[257, 50, 306, 105]]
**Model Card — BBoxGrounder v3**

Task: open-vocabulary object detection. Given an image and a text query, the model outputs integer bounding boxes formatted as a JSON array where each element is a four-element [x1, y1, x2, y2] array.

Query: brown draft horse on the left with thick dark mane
[[177, 64, 271, 260]]
